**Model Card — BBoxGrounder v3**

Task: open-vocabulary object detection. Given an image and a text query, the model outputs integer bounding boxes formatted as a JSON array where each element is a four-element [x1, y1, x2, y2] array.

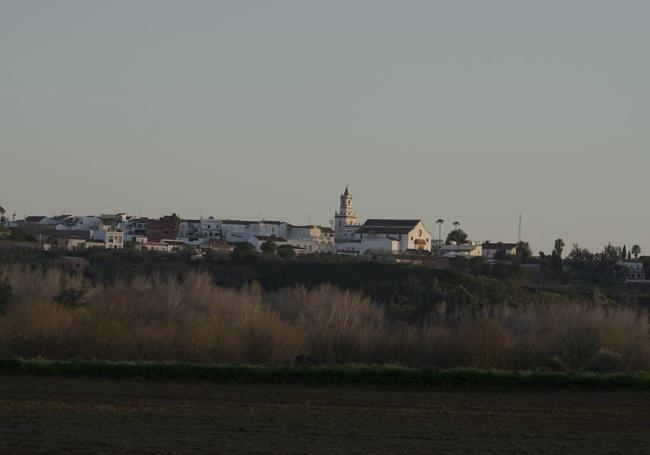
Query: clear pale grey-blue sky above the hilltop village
[[0, 0, 650, 252]]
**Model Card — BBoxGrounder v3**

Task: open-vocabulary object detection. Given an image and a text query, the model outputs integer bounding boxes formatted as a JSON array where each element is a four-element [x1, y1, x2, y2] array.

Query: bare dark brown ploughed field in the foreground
[[0, 376, 650, 454]]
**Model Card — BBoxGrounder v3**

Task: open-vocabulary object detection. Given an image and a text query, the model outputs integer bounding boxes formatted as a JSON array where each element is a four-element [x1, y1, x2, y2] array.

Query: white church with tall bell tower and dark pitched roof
[[334, 187, 432, 255]]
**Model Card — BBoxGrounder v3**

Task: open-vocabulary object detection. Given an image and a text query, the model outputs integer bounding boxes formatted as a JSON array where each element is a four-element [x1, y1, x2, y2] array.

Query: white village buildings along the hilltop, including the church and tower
[[3, 187, 645, 281]]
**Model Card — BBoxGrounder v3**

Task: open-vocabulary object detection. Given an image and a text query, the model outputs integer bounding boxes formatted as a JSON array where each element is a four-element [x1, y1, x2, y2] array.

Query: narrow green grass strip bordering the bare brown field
[[0, 359, 650, 390]]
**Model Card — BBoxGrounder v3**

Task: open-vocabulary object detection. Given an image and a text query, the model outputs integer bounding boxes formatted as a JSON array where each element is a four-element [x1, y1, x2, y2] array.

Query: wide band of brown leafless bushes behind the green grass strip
[[0, 262, 650, 372]]
